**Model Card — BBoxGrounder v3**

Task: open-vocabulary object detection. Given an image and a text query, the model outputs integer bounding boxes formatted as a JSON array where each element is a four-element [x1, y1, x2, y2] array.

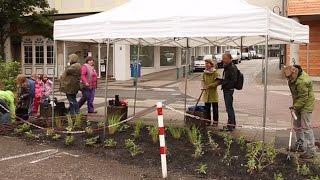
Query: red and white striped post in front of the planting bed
[[157, 102, 168, 178]]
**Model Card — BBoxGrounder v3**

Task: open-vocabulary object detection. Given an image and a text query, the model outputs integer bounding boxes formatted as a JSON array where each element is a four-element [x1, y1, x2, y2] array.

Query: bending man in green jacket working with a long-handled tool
[[284, 65, 316, 159]]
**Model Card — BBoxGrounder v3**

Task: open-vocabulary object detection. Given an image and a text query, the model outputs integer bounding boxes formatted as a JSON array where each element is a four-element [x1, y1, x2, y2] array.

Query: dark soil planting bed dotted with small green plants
[[6, 121, 320, 180]]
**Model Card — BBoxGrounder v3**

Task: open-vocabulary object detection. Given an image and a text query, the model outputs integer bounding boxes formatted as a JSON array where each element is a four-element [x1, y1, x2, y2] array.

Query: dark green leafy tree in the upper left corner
[[0, 0, 56, 60]]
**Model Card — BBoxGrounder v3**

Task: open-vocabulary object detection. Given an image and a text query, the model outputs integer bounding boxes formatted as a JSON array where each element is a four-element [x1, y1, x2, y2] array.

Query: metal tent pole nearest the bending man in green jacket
[[262, 36, 269, 143]]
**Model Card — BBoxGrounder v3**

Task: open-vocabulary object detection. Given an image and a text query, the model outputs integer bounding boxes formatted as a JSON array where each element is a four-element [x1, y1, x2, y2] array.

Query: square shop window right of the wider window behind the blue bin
[[160, 47, 177, 66]]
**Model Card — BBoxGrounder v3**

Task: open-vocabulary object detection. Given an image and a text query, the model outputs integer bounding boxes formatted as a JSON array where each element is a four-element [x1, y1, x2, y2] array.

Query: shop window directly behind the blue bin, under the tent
[[130, 45, 154, 67]]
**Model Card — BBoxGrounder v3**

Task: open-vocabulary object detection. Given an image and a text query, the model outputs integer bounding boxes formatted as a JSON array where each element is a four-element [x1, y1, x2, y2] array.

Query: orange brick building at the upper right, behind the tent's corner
[[287, 0, 320, 76]]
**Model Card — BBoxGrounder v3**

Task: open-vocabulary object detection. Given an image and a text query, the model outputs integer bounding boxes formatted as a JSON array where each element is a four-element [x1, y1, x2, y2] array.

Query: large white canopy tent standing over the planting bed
[[53, 0, 309, 142]]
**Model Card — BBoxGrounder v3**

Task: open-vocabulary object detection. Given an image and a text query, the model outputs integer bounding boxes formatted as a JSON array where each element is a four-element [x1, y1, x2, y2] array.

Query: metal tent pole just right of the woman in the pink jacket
[[105, 38, 110, 140]]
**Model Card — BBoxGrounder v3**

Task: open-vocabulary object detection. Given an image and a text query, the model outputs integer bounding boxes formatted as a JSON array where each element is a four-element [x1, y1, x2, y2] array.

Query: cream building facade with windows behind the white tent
[[9, 0, 298, 80]]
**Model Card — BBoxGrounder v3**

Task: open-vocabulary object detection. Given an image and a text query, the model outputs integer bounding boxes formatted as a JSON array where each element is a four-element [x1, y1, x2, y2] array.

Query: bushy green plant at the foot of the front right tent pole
[[246, 141, 277, 174]]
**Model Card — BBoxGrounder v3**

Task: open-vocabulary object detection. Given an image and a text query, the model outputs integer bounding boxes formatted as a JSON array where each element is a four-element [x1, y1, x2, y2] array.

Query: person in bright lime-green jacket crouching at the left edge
[[0, 91, 16, 123]]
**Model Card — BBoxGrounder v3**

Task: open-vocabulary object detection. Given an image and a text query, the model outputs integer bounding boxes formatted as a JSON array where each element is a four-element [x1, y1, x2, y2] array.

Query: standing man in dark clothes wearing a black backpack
[[221, 53, 243, 131]]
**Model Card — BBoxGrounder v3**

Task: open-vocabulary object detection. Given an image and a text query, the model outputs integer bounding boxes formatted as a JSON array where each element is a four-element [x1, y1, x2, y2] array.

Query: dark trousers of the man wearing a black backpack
[[223, 90, 236, 127]]
